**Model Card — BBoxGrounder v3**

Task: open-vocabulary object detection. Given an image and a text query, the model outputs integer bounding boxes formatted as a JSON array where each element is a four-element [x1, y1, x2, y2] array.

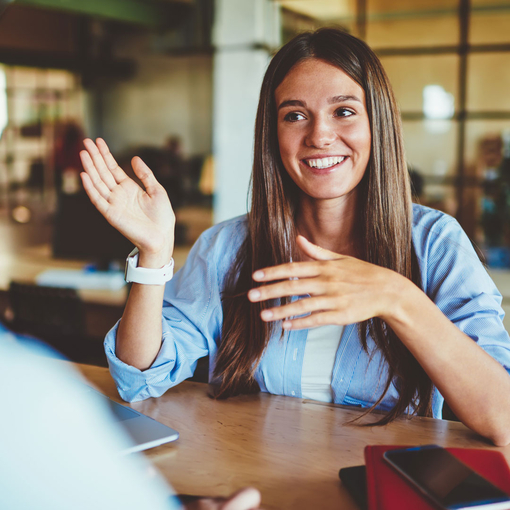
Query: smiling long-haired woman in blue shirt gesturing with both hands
[[78, 29, 510, 445]]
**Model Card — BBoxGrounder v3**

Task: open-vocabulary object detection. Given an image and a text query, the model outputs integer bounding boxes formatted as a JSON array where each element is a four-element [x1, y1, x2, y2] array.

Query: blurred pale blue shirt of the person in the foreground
[[0, 324, 181, 510]]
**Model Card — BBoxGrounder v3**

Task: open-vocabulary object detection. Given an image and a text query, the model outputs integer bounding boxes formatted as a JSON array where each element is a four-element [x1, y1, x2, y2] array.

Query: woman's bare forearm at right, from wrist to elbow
[[383, 280, 510, 446]]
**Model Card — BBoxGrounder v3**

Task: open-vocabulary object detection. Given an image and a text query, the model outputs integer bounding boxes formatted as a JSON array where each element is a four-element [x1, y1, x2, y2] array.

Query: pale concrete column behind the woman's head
[[212, 0, 280, 223]]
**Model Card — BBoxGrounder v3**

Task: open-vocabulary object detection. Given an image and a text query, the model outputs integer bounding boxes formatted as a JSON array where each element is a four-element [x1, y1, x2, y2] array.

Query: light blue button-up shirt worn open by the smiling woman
[[105, 204, 510, 418]]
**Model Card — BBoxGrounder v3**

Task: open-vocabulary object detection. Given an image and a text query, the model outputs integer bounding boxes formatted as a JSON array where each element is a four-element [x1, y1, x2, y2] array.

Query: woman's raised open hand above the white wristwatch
[[80, 138, 175, 266]]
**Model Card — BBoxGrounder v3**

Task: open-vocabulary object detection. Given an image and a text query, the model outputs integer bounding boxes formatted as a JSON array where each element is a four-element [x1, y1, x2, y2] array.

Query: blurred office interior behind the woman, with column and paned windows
[[0, 0, 510, 364]]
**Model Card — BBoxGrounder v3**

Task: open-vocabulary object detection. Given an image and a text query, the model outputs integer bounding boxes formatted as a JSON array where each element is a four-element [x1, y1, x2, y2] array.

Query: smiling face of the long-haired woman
[[275, 58, 371, 199]]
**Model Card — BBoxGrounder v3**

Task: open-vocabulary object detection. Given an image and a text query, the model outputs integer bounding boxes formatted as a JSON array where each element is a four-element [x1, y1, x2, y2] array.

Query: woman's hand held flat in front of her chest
[[248, 236, 411, 329]]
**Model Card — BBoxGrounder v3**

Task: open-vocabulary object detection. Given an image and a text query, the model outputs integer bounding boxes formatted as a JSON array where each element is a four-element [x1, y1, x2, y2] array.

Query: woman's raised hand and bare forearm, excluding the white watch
[[80, 138, 175, 370]]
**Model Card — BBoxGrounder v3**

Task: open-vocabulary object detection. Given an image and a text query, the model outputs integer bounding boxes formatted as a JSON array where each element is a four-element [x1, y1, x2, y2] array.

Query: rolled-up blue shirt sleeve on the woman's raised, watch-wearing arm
[[105, 215, 244, 402]]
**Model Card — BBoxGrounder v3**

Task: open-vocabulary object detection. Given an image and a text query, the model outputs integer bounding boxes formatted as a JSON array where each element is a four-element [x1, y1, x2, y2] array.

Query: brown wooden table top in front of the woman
[[78, 365, 510, 510]]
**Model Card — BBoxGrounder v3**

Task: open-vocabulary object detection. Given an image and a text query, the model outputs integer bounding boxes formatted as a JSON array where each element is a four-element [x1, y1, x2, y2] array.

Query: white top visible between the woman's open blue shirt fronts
[[301, 325, 344, 402]]
